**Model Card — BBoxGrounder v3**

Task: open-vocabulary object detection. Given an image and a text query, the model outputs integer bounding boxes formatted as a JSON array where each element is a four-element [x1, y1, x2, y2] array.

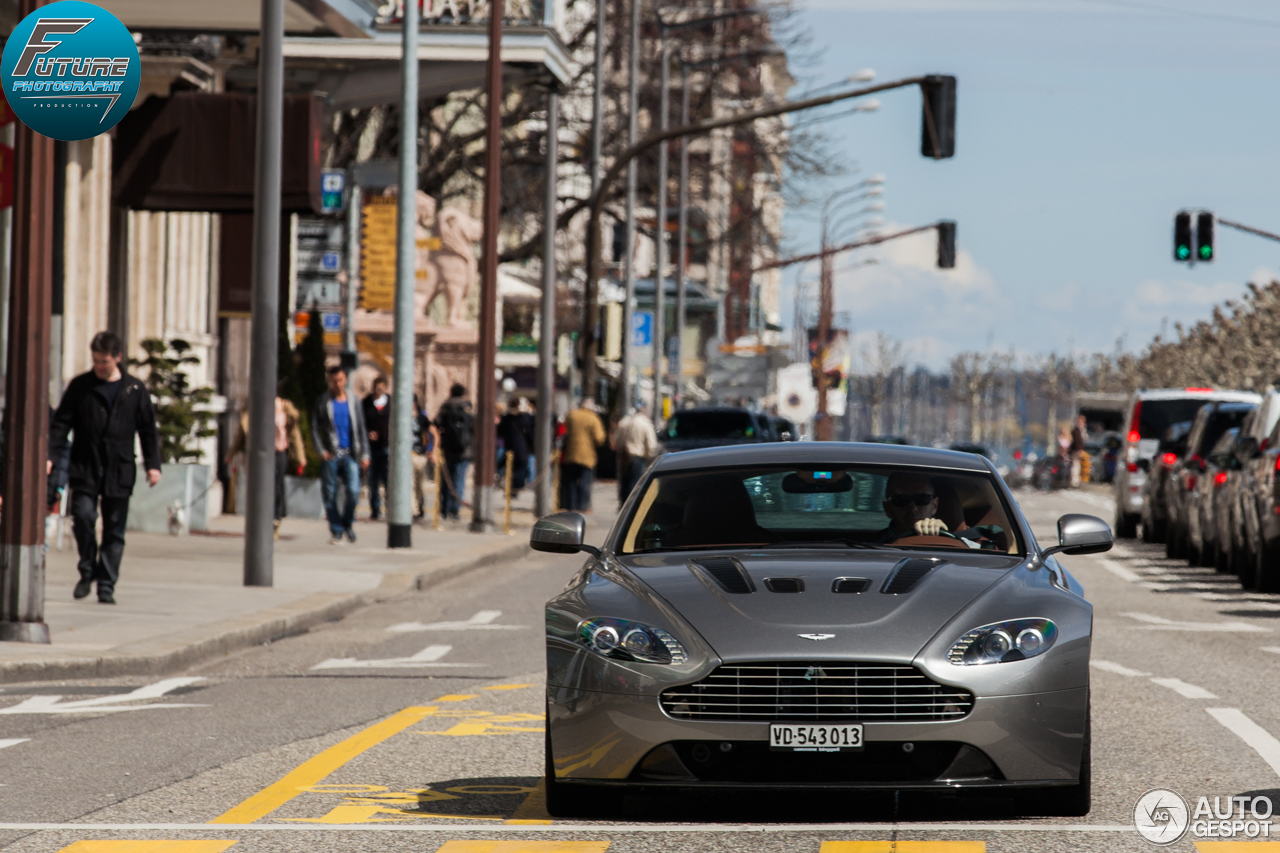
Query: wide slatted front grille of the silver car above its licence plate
[[660, 661, 973, 722]]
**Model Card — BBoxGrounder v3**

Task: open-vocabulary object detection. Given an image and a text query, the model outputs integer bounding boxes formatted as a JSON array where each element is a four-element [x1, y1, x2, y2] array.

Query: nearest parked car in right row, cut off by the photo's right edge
[[1225, 391, 1280, 588]]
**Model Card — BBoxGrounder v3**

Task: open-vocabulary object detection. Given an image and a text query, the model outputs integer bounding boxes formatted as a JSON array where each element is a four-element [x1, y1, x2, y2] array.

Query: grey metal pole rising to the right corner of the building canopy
[[534, 89, 563, 517]]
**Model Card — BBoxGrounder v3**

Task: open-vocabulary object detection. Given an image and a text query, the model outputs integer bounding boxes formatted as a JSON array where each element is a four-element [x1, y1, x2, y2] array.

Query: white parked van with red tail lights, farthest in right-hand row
[[1114, 388, 1262, 539]]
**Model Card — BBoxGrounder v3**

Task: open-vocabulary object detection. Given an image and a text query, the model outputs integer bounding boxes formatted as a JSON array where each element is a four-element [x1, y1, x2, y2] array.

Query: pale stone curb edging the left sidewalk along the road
[[0, 540, 530, 684]]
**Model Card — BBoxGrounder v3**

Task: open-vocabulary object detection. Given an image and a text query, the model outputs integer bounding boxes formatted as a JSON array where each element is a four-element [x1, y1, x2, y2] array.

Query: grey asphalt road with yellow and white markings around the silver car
[[0, 489, 1280, 853]]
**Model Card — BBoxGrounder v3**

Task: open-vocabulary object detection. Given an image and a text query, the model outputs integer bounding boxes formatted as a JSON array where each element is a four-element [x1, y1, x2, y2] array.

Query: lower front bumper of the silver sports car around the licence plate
[[547, 688, 1088, 789]]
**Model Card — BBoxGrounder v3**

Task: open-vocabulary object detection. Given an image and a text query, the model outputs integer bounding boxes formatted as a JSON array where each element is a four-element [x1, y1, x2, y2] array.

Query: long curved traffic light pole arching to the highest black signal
[[581, 76, 945, 388]]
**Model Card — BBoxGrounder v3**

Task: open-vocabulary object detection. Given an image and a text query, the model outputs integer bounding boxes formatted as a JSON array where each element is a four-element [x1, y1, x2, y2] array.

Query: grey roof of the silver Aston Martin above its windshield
[[654, 442, 991, 474]]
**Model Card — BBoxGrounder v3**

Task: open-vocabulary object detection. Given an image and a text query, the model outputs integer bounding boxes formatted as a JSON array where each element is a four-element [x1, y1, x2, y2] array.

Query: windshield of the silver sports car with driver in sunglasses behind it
[[620, 464, 1023, 553]]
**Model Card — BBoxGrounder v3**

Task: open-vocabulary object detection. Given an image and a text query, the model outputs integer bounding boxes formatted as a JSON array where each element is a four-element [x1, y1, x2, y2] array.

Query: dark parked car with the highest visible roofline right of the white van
[[1165, 394, 1261, 566]]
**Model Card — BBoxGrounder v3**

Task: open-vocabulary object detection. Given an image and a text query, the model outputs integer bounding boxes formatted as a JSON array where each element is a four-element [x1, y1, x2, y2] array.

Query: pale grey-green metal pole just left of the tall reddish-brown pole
[[387, 0, 419, 548]]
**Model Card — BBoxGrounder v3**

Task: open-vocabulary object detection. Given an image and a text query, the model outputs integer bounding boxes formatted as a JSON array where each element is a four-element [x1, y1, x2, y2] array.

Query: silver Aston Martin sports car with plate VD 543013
[[532, 442, 1111, 816]]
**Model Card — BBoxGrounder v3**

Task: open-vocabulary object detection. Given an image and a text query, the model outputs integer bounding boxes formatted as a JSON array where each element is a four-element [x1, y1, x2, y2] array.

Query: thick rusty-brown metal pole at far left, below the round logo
[[0, 0, 54, 643]]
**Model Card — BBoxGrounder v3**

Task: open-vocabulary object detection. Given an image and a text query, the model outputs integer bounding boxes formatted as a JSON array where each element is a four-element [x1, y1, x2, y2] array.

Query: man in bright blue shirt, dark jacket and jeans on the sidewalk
[[311, 368, 369, 544]]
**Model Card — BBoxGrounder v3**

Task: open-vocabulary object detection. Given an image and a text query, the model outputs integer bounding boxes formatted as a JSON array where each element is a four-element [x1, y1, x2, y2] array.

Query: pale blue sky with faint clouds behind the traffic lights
[[781, 0, 1280, 368]]
